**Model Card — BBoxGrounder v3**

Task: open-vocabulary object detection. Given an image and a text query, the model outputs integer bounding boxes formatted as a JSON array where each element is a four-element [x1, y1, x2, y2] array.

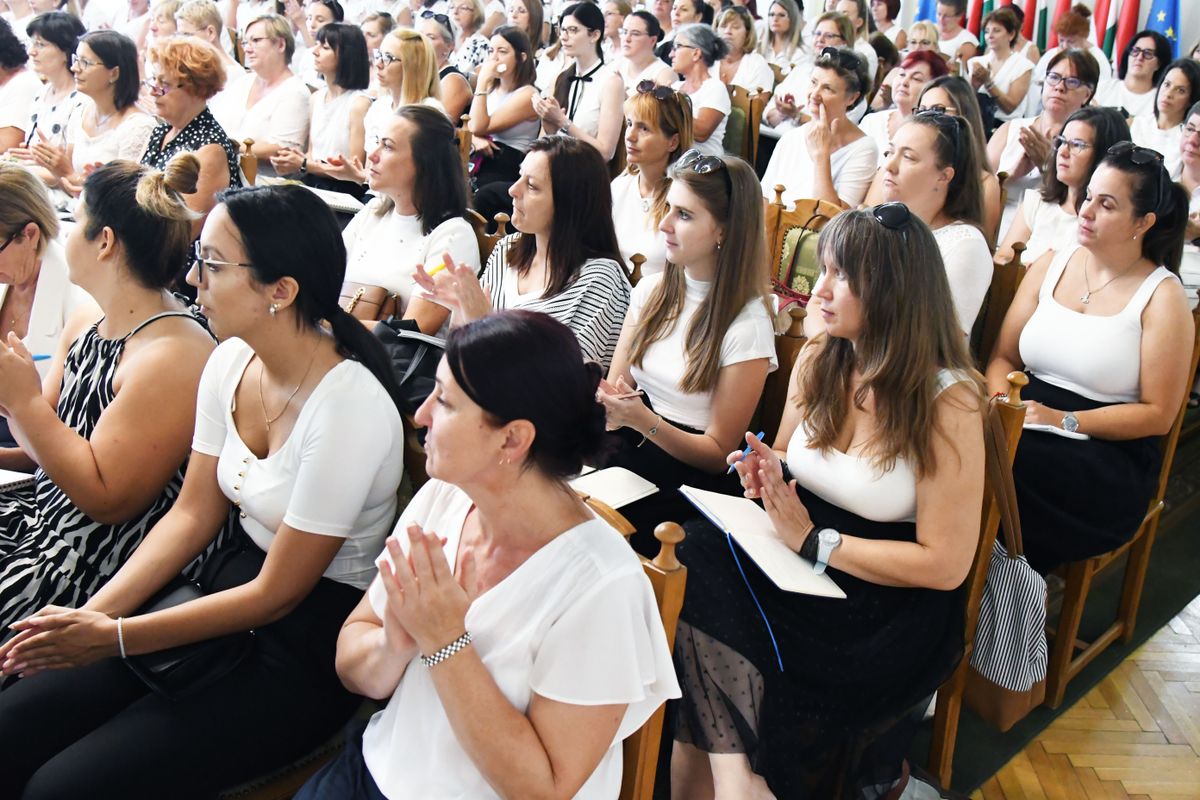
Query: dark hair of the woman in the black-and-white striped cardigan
[[509, 136, 624, 297]]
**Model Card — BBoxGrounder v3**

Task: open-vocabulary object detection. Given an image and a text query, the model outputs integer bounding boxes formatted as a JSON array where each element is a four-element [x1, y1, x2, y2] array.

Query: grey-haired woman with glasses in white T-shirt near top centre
[[671, 23, 733, 156]]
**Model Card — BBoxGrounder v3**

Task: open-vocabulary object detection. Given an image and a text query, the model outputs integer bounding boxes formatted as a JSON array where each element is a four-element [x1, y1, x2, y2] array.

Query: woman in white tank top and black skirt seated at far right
[[988, 142, 1192, 573]]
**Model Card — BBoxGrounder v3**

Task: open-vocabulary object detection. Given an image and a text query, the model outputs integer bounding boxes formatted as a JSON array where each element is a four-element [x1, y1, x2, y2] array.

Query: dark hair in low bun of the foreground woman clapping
[[445, 309, 606, 481]]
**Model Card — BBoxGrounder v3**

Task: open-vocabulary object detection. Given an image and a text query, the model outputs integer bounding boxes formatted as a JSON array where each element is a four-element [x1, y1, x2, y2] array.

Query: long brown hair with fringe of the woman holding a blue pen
[[798, 209, 984, 476]]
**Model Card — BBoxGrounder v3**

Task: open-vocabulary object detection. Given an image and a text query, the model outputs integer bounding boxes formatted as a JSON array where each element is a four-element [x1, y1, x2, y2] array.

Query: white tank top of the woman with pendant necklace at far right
[[1020, 246, 1178, 403]]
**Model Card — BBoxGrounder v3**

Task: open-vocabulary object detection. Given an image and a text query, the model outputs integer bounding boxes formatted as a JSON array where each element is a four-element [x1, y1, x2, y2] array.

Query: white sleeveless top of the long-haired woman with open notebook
[[787, 369, 970, 522]]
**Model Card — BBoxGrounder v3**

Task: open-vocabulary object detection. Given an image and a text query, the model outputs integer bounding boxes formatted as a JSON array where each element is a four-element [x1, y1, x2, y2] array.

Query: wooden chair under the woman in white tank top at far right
[[1046, 309, 1200, 709]]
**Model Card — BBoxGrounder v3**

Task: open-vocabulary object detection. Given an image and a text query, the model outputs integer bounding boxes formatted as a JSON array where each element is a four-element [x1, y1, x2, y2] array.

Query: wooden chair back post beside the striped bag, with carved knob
[[929, 372, 1030, 787]]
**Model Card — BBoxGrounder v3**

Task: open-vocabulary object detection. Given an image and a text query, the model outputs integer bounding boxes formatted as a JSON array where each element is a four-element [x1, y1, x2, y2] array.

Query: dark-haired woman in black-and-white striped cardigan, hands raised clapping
[[416, 136, 629, 367]]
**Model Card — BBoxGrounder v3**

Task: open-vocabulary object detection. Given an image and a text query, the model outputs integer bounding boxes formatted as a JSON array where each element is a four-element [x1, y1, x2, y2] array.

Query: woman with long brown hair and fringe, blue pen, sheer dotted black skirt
[[671, 203, 985, 798]]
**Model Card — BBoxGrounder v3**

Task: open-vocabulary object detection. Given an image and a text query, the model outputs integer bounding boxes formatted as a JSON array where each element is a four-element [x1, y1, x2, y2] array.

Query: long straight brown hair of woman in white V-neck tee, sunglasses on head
[[629, 156, 767, 392]]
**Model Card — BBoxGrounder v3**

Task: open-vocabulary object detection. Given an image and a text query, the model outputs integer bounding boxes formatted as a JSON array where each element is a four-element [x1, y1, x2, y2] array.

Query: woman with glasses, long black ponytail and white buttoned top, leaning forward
[[0, 179, 403, 799]]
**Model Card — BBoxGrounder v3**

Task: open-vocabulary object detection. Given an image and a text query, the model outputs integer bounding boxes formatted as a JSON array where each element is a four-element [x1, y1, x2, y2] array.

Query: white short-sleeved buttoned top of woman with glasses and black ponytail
[[192, 338, 404, 589]]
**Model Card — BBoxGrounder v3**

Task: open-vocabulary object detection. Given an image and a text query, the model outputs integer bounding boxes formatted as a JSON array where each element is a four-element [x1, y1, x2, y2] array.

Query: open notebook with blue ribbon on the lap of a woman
[[679, 486, 846, 600]]
